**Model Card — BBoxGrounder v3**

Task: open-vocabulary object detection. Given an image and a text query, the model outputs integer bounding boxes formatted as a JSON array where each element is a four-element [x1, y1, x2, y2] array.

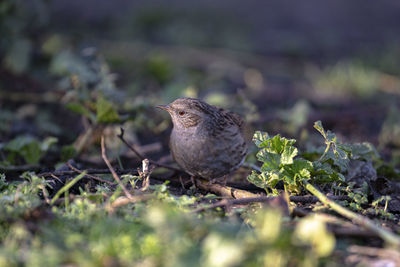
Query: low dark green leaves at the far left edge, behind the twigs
[[1, 135, 57, 165]]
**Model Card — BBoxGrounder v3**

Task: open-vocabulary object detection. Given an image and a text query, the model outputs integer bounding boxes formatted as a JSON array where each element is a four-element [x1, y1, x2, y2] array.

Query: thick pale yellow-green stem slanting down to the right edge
[[303, 181, 400, 247]]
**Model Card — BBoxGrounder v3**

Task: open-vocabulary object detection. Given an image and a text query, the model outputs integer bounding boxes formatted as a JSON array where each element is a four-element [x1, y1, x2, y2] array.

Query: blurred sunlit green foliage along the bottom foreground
[[0, 174, 335, 266]]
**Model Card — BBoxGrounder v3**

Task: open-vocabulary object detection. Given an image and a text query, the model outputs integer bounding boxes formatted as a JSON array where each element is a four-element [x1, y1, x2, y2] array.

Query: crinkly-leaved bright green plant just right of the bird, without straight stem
[[247, 121, 378, 195]]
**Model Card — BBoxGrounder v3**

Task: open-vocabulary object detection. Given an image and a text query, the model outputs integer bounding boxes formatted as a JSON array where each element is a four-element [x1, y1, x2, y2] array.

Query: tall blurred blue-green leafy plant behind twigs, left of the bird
[[50, 49, 121, 124]]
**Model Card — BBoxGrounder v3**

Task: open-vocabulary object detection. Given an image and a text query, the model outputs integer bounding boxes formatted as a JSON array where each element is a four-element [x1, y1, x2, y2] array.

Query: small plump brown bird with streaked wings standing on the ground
[[157, 98, 247, 180]]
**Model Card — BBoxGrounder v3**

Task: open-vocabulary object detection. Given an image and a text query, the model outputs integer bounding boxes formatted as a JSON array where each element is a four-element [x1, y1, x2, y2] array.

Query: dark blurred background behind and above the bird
[[0, 0, 400, 171]]
